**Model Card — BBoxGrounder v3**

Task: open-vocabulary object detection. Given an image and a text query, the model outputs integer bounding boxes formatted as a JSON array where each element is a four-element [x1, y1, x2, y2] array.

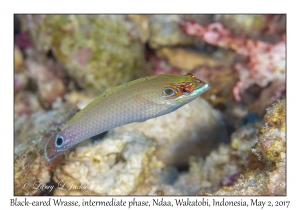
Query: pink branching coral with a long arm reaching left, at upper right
[[183, 22, 286, 101]]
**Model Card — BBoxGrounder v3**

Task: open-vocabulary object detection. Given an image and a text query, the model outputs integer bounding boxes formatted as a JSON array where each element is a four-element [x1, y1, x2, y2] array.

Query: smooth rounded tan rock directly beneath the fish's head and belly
[[111, 98, 227, 165]]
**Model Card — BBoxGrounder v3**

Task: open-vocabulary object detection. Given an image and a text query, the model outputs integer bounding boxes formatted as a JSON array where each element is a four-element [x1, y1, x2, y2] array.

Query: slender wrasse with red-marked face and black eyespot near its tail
[[44, 73, 209, 162]]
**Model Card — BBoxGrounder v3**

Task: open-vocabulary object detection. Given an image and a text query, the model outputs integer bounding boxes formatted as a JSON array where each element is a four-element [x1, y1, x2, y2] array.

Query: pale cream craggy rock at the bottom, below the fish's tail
[[54, 132, 162, 195]]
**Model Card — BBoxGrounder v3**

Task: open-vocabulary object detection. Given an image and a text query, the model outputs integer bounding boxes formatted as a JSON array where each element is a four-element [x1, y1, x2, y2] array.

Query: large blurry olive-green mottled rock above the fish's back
[[20, 15, 144, 94]]
